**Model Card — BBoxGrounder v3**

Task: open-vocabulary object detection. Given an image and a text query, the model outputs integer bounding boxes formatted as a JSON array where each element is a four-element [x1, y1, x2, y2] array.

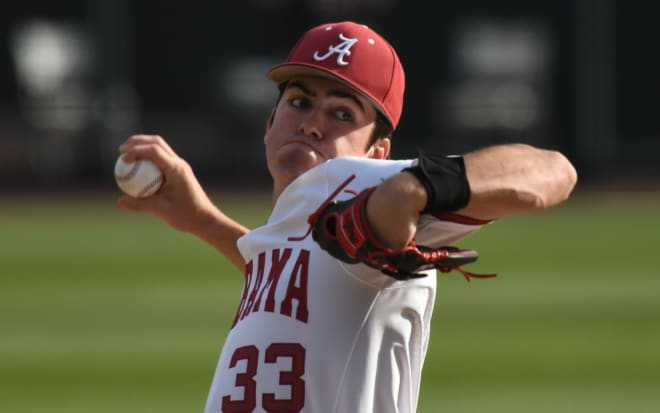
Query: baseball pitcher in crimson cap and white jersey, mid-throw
[[119, 22, 577, 413]]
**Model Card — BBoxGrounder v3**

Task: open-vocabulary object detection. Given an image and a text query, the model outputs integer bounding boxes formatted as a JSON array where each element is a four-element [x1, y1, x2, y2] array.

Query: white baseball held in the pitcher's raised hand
[[115, 156, 163, 198]]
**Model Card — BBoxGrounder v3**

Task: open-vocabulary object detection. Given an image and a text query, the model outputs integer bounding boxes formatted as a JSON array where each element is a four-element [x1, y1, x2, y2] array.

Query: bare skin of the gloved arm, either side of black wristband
[[367, 144, 577, 248]]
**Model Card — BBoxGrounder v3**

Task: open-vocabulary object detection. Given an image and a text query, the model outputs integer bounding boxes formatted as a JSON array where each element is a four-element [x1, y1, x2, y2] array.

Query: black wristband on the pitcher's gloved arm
[[403, 153, 471, 214]]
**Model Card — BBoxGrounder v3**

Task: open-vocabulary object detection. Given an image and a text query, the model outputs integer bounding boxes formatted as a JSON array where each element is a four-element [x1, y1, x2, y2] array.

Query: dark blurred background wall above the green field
[[0, 0, 660, 192]]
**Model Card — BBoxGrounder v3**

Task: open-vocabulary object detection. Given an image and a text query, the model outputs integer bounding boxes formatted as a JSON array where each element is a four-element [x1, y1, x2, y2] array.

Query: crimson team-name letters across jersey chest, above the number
[[232, 248, 309, 328]]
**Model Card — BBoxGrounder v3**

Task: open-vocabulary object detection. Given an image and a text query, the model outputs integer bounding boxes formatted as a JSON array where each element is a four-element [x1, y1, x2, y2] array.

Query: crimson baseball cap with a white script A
[[268, 21, 405, 129]]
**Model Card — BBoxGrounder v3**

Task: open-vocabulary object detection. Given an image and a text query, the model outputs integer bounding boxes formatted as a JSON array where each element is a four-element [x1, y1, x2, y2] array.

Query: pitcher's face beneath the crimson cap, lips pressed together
[[264, 77, 389, 192]]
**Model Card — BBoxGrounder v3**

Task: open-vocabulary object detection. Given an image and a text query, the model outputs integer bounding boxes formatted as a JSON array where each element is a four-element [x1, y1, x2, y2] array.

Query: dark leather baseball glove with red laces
[[290, 175, 494, 281]]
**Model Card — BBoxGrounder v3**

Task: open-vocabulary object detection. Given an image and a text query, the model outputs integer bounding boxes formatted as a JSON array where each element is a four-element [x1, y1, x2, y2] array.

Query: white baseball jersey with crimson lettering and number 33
[[205, 158, 484, 413]]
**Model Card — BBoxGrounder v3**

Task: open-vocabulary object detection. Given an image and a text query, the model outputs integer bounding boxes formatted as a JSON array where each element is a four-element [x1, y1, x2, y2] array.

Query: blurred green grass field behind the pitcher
[[0, 188, 660, 413]]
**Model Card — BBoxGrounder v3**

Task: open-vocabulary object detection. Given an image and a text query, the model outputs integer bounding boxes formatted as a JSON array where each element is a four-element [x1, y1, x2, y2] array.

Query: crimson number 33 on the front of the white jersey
[[222, 343, 305, 413]]
